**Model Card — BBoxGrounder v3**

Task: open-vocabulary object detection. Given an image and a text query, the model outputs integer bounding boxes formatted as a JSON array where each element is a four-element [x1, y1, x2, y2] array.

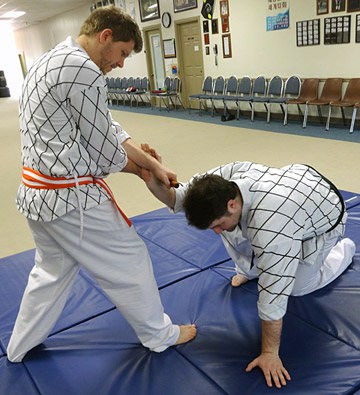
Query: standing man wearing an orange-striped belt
[[7, 7, 196, 362]]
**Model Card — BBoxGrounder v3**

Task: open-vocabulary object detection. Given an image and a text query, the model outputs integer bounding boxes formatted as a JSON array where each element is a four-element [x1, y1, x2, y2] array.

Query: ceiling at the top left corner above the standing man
[[0, 0, 95, 30]]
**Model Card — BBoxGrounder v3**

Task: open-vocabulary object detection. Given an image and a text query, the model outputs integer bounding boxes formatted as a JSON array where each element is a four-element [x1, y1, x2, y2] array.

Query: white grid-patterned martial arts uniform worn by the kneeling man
[[174, 162, 355, 321]]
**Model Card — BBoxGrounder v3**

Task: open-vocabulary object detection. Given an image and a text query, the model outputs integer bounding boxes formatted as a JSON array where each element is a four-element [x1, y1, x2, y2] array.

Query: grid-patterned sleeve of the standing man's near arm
[[68, 86, 130, 173]]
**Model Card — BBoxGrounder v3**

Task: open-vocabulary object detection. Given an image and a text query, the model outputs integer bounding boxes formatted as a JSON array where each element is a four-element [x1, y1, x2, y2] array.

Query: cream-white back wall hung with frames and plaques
[[11, 0, 360, 90]]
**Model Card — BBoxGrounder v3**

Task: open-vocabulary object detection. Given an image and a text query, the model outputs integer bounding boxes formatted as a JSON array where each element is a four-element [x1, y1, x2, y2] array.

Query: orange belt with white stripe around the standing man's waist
[[22, 167, 132, 226]]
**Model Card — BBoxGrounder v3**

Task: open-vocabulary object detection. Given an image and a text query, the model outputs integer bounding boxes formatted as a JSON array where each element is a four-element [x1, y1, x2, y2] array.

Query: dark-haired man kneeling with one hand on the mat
[[143, 160, 355, 388]]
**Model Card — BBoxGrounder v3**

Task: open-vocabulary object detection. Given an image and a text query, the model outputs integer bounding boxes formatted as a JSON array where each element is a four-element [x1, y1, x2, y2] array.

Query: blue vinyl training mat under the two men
[[0, 192, 360, 395]]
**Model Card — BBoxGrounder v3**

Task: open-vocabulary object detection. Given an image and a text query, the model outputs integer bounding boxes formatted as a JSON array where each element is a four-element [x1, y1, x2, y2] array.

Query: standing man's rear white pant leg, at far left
[[7, 220, 79, 362]]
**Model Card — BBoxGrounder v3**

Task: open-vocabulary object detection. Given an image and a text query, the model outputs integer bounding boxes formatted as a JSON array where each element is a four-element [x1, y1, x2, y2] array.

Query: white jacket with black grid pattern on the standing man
[[17, 39, 127, 221]]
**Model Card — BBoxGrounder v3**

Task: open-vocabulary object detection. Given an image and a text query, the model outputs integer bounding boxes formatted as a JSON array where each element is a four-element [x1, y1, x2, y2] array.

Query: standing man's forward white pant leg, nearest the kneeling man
[[45, 201, 180, 352]]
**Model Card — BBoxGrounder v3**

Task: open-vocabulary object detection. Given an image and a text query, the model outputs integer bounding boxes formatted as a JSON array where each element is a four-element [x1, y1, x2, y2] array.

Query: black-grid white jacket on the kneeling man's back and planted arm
[[205, 162, 342, 314]]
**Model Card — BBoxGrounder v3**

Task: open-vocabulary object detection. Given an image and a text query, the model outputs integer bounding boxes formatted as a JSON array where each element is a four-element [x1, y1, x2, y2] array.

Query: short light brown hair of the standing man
[[79, 6, 143, 53]]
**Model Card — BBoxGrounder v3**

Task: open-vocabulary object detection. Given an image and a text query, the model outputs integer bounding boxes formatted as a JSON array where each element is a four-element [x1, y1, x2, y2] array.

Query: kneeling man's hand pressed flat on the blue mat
[[245, 353, 291, 388]]
